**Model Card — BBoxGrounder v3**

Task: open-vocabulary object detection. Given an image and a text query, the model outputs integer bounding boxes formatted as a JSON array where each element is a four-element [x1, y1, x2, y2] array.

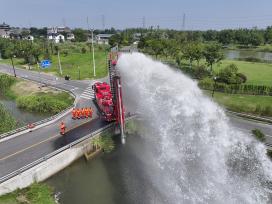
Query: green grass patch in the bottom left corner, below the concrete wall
[[0, 183, 55, 204]]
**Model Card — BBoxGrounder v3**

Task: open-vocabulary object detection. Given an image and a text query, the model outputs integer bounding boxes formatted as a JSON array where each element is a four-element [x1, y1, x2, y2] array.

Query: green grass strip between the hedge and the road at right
[[205, 91, 272, 116]]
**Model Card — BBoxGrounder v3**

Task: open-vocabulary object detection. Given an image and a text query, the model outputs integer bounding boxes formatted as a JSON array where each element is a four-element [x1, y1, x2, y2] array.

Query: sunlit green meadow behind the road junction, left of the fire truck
[[0, 50, 108, 80]]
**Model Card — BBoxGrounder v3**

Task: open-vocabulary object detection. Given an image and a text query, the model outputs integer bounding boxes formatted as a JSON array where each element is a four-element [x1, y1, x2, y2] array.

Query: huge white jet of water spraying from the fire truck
[[118, 53, 272, 203]]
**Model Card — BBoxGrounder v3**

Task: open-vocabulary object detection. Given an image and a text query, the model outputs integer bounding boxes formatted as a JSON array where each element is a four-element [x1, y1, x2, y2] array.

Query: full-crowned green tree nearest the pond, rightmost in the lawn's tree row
[[203, 43, 224, 71]]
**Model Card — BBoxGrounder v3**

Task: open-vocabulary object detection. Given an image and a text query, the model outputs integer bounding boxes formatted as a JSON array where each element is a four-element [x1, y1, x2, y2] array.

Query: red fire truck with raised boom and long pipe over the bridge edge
[[92, 52, 125, 144]]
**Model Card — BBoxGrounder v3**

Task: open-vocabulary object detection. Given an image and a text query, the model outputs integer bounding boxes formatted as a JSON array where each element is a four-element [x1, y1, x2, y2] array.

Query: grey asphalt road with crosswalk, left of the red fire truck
[[0, 65, 110, 177]]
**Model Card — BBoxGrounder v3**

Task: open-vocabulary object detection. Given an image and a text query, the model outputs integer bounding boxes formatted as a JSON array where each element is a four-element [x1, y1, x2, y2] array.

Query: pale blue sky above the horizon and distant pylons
[[0, 0, 272, 30]]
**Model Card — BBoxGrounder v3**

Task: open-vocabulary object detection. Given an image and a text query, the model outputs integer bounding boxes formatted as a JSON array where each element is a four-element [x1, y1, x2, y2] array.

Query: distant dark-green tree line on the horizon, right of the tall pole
[[110, 26, 272, 47]]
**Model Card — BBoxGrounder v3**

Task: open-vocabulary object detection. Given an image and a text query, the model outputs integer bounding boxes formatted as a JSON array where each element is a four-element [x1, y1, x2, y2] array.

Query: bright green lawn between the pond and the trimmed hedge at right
[[214, 60, 272, 86]]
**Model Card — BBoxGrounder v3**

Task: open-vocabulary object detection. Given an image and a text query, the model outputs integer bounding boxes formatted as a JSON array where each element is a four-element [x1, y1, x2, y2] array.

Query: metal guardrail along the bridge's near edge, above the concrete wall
[[0, 115, 137, 183]]
